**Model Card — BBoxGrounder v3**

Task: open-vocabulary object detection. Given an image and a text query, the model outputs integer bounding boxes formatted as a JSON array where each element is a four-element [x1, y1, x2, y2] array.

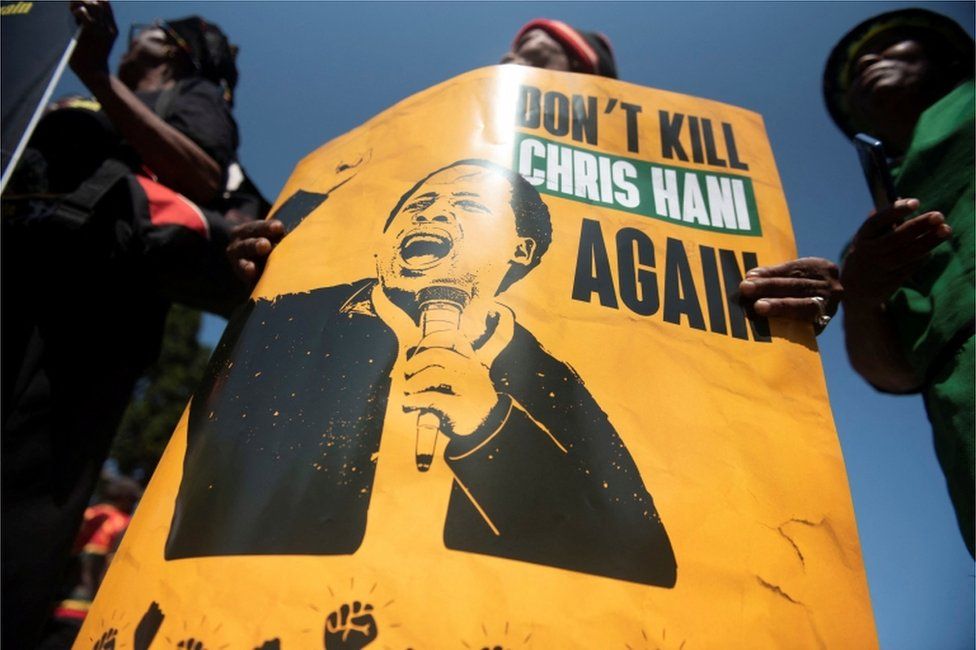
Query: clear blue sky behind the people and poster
[[51, 2, 974, 650]]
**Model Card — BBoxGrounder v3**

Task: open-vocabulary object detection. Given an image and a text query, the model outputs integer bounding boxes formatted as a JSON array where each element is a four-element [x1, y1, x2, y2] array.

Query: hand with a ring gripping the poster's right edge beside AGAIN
[[739, 257, 844, 334]]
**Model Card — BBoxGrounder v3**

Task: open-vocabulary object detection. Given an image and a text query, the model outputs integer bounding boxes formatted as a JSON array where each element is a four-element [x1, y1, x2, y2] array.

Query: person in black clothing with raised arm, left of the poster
[[2, 1, 256, 648]]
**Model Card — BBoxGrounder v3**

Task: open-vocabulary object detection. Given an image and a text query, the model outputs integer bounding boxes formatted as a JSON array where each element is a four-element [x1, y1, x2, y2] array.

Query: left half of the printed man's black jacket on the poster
[[166, 281, 397, 560]]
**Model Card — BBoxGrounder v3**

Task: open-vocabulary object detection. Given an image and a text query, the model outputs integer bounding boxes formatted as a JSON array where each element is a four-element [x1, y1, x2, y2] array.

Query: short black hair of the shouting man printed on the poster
[[383, 158, 552, 293]]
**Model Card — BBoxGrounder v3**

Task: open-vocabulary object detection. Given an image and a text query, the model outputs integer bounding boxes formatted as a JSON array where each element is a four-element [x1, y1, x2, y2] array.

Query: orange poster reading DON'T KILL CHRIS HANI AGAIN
[[82, 66, 877, 650]]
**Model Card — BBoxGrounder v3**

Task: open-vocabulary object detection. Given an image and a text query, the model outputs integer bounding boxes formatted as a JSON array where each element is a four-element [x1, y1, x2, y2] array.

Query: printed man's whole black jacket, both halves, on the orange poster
[[166, 280, 676, 587]]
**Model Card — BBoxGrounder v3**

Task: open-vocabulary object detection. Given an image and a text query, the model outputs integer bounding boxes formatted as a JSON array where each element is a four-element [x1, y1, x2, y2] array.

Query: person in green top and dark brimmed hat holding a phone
[[824, 9, 976, 554]]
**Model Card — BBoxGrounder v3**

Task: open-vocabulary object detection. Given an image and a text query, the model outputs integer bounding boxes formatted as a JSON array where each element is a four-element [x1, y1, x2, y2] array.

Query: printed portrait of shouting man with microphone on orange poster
[[166, 160, 676, 587]]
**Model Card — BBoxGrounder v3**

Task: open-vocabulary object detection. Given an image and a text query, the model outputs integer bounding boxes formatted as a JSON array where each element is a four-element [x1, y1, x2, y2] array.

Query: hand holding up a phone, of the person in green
[[841, 199, 952, 307]]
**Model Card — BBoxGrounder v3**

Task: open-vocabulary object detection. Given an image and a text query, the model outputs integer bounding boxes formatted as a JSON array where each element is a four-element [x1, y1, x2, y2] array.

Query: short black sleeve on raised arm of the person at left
[[165, 79, 238, 172]]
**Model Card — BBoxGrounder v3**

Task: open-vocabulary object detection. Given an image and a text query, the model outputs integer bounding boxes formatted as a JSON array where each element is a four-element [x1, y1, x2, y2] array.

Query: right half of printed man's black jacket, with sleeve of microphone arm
[[444, 328, 677, 587]]
